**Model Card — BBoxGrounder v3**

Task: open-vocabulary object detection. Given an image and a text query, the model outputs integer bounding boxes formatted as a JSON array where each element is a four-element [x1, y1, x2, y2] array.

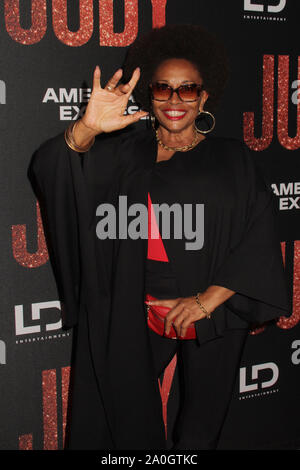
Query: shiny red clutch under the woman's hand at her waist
[[145, 294, 196, 339]]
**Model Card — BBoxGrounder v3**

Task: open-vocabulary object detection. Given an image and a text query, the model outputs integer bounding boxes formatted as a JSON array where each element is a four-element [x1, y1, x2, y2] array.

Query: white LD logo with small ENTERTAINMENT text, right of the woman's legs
[[239, 362, 279, 400]]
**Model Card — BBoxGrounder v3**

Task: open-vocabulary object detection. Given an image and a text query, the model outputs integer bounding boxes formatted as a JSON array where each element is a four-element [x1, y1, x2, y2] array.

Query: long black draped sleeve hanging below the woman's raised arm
[[28, 135, 81, 328]]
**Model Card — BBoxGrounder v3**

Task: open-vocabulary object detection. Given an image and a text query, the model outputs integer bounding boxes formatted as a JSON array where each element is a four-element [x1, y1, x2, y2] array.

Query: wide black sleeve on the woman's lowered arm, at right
[[212, 143, 291, 324]]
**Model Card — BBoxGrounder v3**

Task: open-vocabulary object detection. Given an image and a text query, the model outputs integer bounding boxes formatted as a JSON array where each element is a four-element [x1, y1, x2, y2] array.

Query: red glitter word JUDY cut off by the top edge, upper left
[[4, 0, 167, 47]]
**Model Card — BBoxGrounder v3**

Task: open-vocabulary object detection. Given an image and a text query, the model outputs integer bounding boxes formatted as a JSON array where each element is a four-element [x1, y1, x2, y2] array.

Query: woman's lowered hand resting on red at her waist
[[147, 295, 211, 338]]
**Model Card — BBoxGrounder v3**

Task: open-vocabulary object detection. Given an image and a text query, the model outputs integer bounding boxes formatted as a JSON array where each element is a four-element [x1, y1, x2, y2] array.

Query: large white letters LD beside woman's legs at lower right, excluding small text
[[240, 362, 279, 393]]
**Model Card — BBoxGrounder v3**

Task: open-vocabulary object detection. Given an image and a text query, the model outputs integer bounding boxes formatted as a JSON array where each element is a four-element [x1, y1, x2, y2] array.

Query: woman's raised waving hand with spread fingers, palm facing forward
[[73, 66, 148, 146]]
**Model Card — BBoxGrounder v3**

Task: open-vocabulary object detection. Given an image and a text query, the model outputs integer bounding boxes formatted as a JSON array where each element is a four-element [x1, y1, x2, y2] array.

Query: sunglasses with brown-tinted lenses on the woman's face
[[149, 82, 203, 101]]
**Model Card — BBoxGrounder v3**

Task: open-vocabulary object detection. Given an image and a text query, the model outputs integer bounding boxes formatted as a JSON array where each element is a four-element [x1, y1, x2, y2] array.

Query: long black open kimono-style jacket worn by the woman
[[29, 129, 290, 449]]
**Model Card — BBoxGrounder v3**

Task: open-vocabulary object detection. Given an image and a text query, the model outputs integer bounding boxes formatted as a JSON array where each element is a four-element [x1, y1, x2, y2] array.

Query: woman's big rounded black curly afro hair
[[121, 24, 229, 111]]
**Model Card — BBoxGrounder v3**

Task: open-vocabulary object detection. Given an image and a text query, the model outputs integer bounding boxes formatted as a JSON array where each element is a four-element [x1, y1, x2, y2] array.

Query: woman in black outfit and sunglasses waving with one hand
[[30, 25, 289, 449]]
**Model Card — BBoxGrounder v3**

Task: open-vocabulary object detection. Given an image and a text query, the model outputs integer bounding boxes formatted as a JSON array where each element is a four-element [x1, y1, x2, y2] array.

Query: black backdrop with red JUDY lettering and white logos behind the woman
[[0, 0, 300, 450]]
